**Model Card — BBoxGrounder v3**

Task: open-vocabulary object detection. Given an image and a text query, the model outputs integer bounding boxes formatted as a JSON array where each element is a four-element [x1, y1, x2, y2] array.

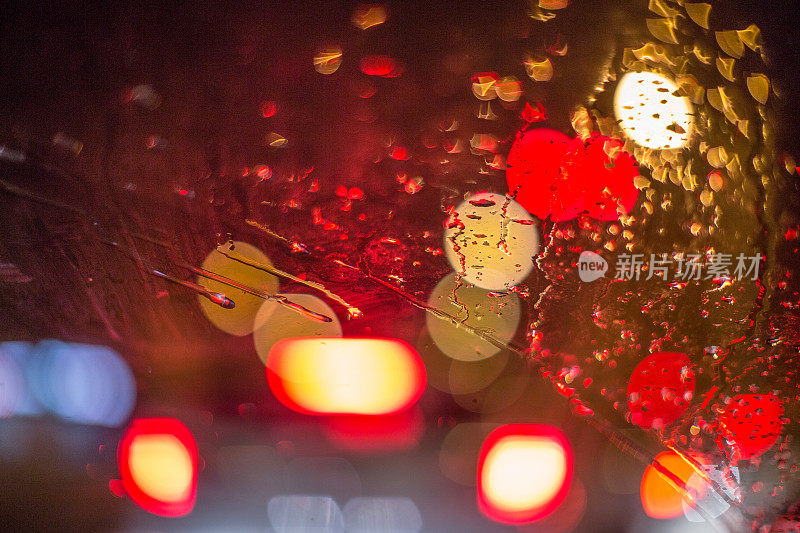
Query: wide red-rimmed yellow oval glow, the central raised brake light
[[267, 337, 426, 415]]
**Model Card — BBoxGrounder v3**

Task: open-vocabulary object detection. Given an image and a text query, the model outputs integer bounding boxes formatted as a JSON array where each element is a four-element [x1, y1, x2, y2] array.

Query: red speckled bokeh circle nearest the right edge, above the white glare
[[717, 394, 783, 460]]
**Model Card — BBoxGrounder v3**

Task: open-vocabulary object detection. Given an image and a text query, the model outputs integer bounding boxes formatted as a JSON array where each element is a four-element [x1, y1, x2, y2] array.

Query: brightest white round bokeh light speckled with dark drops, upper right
[[614, 72, 694, 150]]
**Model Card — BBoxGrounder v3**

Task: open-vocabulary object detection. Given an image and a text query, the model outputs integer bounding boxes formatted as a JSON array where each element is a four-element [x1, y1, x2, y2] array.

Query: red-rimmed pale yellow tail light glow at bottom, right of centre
[[478, 424, 572, 524]]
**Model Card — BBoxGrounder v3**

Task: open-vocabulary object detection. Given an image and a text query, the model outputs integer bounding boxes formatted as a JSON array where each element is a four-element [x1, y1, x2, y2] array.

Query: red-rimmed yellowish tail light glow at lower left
[[117, 418, 197, 517]]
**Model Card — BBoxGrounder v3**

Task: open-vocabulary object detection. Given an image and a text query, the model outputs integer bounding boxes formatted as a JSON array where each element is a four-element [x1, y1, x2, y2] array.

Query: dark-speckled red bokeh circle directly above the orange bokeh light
[[628, 352, 695, 429]]
